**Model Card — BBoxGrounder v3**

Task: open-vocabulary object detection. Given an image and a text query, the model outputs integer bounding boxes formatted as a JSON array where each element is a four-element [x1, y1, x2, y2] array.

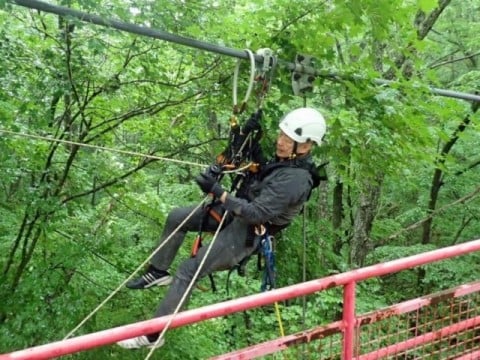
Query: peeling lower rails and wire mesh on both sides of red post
[[213, 281, 480, 360]]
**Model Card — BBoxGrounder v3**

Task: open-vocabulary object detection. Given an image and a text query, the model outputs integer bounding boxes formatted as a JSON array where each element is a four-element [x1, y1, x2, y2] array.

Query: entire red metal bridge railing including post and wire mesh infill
[[0, 240, 480, 360]]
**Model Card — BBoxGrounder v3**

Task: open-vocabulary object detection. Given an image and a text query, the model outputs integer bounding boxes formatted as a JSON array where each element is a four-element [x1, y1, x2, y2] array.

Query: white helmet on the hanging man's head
[[279, 108, 327, 145]]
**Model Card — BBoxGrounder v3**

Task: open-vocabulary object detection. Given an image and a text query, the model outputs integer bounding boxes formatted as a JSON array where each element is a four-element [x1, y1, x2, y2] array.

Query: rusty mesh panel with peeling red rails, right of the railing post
[[356, 281, 480, 360]]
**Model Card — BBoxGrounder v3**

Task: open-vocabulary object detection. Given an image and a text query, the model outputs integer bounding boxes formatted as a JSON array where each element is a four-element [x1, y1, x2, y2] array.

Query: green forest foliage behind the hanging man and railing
[[0, 0, 480, 359]]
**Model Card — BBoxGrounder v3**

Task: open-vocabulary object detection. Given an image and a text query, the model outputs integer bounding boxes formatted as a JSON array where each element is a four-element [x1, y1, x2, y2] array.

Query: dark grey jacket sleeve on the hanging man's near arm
[[224, 168, 311, 224]]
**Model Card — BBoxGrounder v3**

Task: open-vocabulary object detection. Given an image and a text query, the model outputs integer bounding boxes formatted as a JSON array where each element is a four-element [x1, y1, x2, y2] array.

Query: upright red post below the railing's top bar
[[342, 281, 356, 360]]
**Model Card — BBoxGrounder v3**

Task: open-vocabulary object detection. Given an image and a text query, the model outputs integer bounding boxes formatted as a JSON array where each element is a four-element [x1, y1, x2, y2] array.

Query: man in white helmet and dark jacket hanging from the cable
[[118, 108, 326, 349]]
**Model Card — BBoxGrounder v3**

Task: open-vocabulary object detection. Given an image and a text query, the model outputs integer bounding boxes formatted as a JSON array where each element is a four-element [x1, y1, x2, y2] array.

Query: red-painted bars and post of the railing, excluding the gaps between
[[0, 240, 480, 360]]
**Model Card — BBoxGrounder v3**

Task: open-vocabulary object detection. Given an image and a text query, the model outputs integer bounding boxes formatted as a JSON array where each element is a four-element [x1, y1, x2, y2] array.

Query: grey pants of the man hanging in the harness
[[151, 206, 256, 317]]
